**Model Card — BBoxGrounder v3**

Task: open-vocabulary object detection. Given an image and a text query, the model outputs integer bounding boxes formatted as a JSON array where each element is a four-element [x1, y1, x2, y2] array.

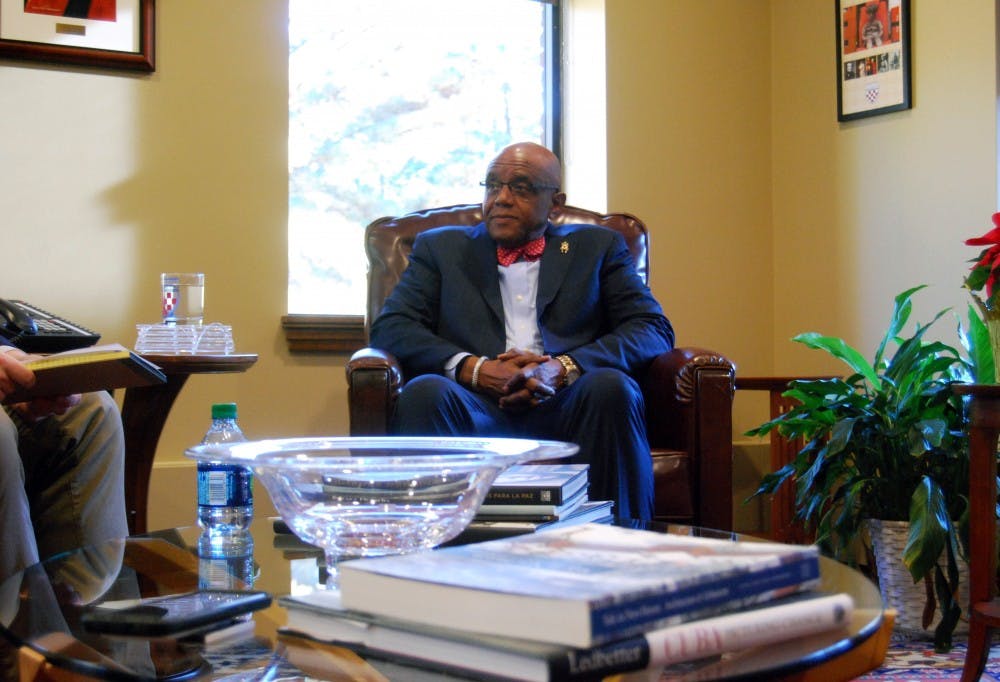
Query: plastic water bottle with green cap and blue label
[[198, 403, 253, 554]]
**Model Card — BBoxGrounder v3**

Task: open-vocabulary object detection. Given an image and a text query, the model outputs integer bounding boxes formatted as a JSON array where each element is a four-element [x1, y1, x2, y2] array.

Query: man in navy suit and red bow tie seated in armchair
[[371, 143, 674, 519]]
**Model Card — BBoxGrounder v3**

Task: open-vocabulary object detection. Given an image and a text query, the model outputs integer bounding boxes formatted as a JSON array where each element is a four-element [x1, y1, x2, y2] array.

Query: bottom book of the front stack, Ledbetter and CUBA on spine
[[278, 592, 854, 682]]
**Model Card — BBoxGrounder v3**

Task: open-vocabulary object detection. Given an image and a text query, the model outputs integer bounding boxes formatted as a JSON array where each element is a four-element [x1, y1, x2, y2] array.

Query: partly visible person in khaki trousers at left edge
[[0, 346, 128, 580]]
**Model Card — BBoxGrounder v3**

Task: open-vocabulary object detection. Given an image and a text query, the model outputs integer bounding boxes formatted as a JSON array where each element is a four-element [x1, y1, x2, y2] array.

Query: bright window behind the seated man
[[288, 0, 559, 316]]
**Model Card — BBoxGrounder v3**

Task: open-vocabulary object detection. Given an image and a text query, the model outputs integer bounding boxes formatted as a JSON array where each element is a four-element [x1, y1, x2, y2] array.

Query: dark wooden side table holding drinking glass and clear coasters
[[122, 353, 257, 535]]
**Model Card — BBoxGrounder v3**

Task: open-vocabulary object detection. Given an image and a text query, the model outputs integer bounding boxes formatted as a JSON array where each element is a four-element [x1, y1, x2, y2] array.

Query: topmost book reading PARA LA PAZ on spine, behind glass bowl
[[483, 464, 590, 505]]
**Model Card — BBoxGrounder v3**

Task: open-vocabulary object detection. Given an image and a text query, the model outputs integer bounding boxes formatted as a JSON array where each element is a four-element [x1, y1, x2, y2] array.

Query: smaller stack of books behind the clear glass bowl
[[449, 464, 614, 545]]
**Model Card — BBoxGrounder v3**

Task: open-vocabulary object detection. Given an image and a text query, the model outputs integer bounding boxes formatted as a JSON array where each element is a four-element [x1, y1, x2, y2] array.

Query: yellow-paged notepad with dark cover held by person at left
[[3, 344, 167, 403]]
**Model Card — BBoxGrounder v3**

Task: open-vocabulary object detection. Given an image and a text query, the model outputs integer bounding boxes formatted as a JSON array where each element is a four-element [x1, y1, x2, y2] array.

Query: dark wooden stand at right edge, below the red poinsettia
[[953, 384, 1000, 682]]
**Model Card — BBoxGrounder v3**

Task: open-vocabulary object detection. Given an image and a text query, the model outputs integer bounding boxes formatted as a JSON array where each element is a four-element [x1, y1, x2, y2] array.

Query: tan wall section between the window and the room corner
[[607, 0, 776, 433]]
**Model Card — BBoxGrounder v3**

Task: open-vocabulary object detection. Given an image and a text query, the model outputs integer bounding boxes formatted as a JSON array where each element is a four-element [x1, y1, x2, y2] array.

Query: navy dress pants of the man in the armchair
[[391, 368, 653, 519]]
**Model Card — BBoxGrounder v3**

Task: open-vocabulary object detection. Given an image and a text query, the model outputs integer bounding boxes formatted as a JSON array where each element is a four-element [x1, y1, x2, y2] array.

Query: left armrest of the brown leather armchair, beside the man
[[345, 348, 403, 436]]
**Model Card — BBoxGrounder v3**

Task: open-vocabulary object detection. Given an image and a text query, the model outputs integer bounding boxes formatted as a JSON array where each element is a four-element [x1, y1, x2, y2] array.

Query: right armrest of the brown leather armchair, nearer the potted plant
[[642, 347, 736, 530]]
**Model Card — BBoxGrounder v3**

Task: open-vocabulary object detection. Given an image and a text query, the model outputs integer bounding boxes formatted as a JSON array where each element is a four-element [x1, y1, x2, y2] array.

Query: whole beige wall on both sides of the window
[[0, 0, 997, 527]]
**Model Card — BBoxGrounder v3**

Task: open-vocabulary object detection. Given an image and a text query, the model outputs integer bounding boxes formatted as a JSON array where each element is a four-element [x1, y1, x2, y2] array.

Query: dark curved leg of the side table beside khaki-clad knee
[[122, 374, 189, 535]]
